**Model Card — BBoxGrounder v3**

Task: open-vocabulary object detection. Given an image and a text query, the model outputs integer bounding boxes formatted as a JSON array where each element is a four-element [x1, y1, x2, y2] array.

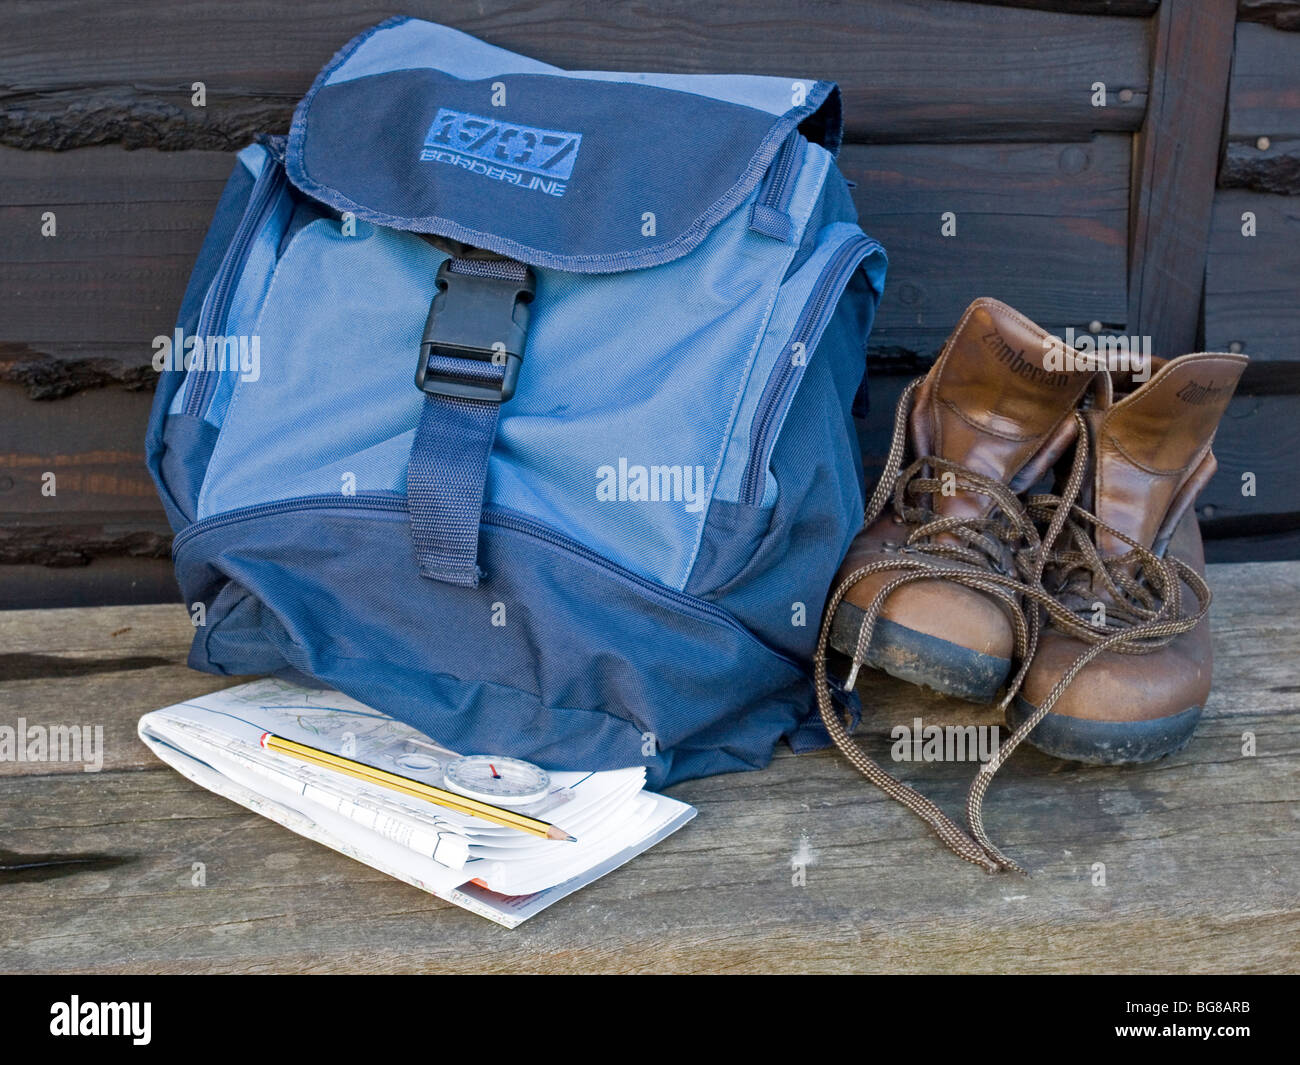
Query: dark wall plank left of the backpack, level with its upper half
[[0, 147, 234, 361]]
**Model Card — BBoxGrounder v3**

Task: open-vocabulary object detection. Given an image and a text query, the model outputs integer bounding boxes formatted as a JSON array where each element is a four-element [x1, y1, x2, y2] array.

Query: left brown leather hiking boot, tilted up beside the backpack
[[829, 299, 1096, 702]]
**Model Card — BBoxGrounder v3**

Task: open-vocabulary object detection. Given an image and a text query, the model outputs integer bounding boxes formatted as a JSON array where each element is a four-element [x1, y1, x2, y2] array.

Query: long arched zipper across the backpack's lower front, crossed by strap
[[172, 494, 807, 676]]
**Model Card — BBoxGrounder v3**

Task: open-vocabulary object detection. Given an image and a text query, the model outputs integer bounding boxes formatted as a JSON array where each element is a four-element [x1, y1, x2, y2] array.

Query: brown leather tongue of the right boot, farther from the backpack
[[1092, 354, 1249, 555]]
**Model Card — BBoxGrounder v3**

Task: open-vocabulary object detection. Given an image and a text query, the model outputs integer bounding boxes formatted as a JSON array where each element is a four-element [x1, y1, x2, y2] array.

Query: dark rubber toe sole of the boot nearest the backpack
[[831, 602, 1011, 702]]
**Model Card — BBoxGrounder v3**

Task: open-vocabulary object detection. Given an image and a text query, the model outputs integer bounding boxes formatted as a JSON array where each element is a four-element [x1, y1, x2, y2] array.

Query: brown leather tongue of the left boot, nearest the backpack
[[911, 299, 1095, 516]]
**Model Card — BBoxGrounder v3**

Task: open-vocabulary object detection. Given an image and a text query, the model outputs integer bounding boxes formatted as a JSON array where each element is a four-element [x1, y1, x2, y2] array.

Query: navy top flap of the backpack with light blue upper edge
[[286, 18, 841, 273]]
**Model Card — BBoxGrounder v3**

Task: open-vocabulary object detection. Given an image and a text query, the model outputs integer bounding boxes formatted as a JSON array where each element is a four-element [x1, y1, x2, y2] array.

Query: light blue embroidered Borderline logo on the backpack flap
[[420, 107, 582, 196]]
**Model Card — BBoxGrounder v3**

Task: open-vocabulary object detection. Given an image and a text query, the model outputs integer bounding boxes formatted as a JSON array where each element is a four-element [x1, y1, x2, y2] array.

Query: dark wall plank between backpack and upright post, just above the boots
[[841, 137, 1130, 358]]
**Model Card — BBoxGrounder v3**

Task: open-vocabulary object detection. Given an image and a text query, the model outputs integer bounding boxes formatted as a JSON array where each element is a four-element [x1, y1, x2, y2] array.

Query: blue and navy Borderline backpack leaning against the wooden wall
[[147, 18, 885, 787]]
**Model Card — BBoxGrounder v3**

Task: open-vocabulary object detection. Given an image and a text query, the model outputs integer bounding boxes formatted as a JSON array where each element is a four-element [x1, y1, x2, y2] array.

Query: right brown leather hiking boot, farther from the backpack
[[1008, 354, 1248, 763]]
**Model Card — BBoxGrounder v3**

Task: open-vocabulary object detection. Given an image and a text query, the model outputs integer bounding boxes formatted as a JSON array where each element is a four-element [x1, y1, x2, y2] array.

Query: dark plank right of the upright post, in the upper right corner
[[1219, 25, 1300, 195]]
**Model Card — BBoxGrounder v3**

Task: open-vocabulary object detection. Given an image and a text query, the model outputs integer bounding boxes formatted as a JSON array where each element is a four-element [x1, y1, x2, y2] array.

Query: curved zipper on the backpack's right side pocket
[[740, 235, 881, 506]]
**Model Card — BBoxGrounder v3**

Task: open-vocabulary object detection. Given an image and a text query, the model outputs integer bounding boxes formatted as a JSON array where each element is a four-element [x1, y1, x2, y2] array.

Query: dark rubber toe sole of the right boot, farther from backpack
[[1006, 696, 1201, 766]]
